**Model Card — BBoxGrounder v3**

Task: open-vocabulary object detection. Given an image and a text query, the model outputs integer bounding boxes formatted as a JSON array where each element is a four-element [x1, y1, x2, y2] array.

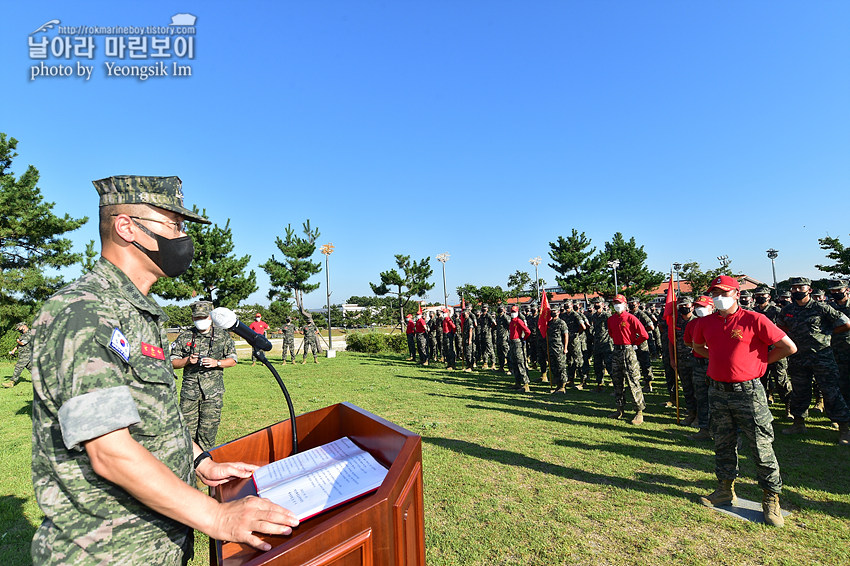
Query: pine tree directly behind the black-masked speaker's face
[[151, 211, 257, 309]]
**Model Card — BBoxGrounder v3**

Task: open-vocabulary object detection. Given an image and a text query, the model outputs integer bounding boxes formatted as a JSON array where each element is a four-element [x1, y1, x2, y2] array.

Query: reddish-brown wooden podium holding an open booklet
[[210, 403, 425, 566]]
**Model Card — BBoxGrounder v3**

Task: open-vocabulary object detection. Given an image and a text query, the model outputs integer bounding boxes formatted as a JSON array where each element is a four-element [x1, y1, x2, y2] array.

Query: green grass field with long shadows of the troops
[[0, 353, 850, 566]]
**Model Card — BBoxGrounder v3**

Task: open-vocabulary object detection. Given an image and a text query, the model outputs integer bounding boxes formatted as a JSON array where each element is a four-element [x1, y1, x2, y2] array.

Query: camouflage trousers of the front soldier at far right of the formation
[[788, 348, 850, 423]]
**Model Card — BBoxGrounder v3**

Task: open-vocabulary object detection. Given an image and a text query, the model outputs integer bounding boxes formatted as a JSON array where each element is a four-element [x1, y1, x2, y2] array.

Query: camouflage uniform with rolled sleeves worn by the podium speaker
[[32, 258, 195, 566]]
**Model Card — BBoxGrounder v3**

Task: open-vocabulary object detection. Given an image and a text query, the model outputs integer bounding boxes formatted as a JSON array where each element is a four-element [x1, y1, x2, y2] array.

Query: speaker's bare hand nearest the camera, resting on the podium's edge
[[207, 495, 298, 551]]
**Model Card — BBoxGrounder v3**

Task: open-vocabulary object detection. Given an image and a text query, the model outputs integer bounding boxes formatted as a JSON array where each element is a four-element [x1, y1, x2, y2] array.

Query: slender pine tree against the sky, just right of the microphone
[[260, 219, 322, 318]]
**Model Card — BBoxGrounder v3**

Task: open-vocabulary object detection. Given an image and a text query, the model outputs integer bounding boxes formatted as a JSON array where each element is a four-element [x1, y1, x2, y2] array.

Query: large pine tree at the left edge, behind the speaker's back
[[0, 133, 88, 335]]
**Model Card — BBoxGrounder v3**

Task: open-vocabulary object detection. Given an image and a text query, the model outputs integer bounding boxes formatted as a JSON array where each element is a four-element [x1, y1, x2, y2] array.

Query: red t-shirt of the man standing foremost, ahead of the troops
[[693, 307, 785, 383]]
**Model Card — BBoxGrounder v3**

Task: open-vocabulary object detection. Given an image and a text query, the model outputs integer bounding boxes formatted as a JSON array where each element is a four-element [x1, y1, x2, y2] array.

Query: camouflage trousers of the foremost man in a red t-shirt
[[708, 379, 782, 493]]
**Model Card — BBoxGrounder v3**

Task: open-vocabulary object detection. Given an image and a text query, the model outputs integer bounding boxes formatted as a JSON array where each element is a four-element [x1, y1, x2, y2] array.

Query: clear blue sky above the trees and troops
[[0, 0, 850, 307]]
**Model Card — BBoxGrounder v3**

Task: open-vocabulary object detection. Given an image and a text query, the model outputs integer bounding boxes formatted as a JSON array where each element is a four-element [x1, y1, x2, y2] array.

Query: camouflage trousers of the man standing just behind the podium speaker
[[180, 378, 224, 450]]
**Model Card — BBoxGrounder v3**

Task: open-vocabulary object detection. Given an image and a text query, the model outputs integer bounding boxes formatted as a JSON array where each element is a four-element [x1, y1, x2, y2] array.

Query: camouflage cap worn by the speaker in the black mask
[[92, 175, 210, 224]]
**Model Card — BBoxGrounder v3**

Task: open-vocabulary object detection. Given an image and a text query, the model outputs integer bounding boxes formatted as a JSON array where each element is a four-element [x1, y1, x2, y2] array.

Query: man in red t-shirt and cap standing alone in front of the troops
[[693, 275, 797, 527]]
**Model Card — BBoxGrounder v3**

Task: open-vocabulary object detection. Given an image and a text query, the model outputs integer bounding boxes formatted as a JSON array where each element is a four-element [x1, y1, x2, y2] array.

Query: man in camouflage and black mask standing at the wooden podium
[[32, 176, 298, 566]]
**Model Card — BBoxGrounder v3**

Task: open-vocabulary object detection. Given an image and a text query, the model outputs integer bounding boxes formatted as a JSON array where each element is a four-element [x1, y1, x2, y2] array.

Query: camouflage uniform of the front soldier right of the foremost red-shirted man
[[780, 292, 850, 423]]
